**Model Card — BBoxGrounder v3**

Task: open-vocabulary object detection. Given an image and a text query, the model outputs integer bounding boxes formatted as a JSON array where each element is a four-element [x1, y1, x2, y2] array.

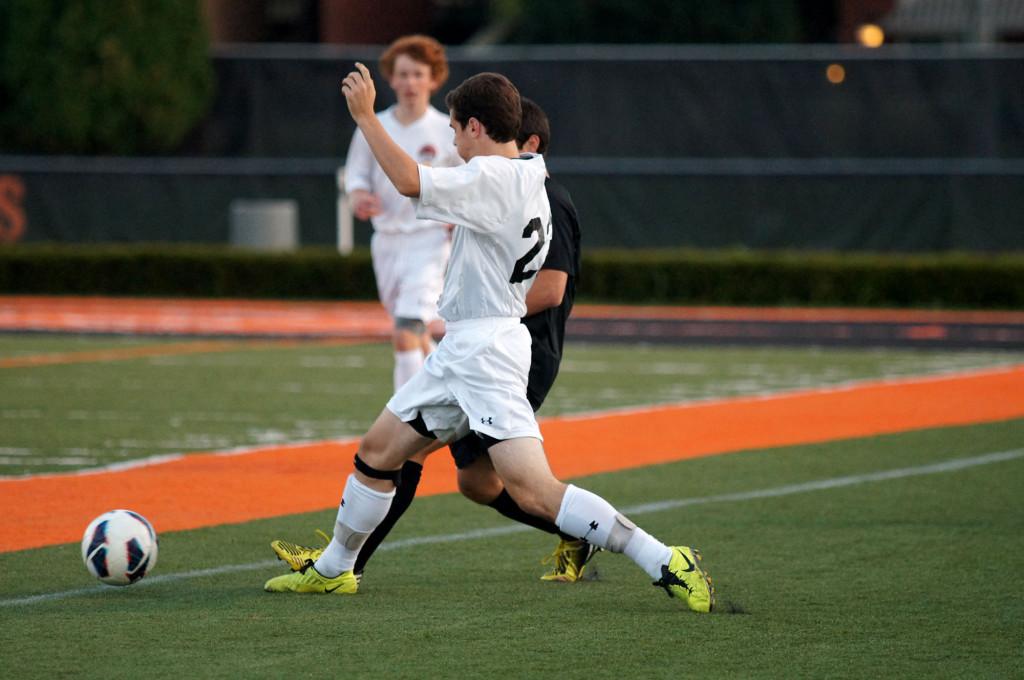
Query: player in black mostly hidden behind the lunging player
[[270, 97, 597, 583]]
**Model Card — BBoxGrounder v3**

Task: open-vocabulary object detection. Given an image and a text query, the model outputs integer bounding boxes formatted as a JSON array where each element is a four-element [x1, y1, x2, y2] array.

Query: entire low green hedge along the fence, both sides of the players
[[0, 245, 1024, 309]]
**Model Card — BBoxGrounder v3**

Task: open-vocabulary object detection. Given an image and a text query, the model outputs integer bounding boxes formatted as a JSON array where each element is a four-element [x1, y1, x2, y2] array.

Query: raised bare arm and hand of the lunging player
[[341, 62, 420, 198]]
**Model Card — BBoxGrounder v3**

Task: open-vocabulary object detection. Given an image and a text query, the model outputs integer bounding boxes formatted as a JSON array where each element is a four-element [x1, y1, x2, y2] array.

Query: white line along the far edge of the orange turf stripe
[[0, 364, 1024, 481]]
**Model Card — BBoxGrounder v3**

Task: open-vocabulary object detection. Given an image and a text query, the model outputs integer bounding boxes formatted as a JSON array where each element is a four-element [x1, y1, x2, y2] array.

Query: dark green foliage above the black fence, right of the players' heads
[[495, 0, 803, 44]]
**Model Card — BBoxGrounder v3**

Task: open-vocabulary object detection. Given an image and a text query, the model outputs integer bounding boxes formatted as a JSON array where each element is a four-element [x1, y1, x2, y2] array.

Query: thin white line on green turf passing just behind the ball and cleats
[[0, 449, 1024, 607]]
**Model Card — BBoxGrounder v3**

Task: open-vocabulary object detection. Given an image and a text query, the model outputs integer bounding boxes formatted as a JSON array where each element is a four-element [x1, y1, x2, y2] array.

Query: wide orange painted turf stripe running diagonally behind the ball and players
[[0, 365, 1024, 552]]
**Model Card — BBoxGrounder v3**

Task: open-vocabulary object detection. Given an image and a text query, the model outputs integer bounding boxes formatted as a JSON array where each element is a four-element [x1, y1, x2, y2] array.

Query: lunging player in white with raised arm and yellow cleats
[[264, 63, 714, 612]]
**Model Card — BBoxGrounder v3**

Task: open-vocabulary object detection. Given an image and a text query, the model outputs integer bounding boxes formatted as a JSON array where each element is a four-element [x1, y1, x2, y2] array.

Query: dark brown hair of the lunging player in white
[[444, 73, 522, 142]]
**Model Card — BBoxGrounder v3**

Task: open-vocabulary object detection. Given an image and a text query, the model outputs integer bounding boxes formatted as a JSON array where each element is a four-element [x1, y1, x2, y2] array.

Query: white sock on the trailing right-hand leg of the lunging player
[[555, 484, 672, 579]]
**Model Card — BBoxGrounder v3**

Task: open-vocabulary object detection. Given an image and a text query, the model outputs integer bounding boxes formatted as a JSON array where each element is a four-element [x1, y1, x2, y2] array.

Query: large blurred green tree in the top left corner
[[0, 0, 213, 155]]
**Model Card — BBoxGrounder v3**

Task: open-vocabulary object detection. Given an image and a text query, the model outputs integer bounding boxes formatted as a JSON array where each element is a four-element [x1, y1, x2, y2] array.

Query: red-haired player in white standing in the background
[[345, 35, 462, 389]]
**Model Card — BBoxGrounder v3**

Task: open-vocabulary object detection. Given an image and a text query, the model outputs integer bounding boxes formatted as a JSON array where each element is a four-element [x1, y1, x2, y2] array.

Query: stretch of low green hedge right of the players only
[[582, 251, 1024, 308]]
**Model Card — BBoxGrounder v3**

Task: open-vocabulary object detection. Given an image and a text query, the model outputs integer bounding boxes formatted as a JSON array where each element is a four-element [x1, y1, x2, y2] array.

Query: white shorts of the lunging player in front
[[387, 318, 543, 442]]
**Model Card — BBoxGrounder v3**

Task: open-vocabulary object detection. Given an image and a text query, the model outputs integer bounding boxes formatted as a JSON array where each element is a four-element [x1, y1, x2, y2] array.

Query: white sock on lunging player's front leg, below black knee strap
[[313, 474, 394, 579]]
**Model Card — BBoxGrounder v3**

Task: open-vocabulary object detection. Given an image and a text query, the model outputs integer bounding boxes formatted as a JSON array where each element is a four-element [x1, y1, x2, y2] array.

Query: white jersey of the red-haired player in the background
[[345, 107, 462, 233]]
